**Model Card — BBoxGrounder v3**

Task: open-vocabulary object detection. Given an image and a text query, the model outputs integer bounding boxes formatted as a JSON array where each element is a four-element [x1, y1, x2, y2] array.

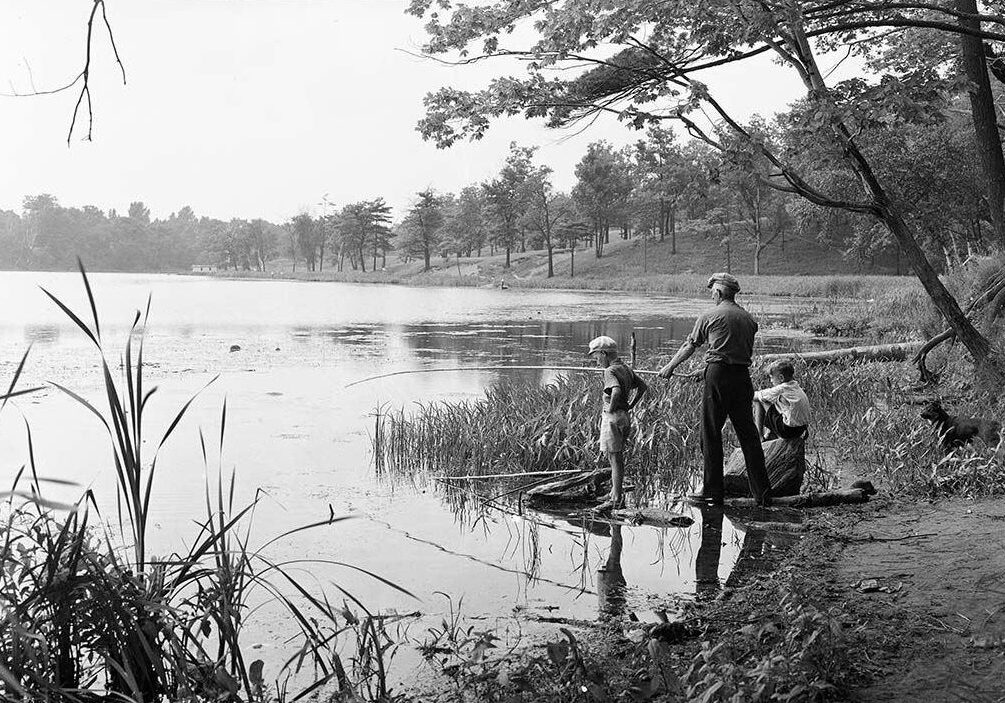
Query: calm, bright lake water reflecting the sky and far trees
[[0, 272, 808, 678]]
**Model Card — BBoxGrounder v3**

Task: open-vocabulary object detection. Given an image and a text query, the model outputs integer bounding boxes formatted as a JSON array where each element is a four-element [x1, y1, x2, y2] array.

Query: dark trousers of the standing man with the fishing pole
[[701, 364, 771, 500]]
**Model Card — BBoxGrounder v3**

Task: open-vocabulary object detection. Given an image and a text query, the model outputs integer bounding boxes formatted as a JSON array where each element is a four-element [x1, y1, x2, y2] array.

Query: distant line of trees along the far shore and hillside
[[0, 115, 988, 276]]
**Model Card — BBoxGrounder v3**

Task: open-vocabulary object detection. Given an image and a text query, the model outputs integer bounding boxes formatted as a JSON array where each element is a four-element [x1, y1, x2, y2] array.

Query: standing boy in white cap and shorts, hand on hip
[[587, 336, 648, 512]]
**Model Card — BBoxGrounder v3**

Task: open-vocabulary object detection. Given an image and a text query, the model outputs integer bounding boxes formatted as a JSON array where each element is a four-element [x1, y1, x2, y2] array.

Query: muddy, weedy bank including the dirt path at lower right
[[397, 499, 1005, 703]]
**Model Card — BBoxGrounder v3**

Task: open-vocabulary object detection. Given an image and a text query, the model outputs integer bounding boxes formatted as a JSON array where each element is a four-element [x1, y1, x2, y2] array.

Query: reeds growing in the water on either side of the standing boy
[[371, 374, 699, 506]]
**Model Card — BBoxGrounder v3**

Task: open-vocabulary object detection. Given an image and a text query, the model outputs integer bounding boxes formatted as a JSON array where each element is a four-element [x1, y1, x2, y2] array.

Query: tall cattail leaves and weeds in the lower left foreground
[[0, 266, 408, 703]]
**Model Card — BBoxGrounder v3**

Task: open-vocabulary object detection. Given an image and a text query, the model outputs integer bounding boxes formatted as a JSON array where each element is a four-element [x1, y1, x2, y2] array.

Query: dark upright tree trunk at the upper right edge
[[956, 0, 1005, 244]]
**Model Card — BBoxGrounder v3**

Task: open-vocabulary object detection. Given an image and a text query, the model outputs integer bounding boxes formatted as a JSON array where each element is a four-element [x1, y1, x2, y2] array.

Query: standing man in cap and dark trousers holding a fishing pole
[[659, 273, 771, 505]]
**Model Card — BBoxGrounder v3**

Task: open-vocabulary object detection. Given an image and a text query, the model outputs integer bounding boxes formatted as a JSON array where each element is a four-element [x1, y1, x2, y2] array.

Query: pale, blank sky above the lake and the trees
[[0, 0, 801, 222]]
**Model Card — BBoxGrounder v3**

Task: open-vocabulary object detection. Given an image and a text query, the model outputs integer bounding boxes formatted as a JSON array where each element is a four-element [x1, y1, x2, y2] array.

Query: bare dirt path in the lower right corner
[[824, 499, 1005, 701]]
